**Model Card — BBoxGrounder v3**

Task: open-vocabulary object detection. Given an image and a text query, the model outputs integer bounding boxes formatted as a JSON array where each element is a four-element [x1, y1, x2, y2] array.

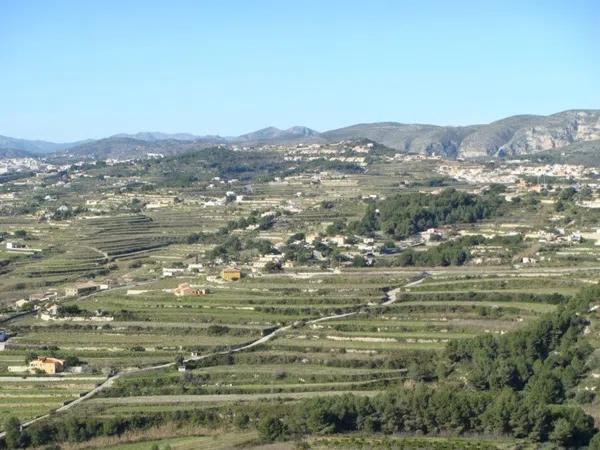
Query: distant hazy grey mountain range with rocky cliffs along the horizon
[[0, 110, 600, 158]]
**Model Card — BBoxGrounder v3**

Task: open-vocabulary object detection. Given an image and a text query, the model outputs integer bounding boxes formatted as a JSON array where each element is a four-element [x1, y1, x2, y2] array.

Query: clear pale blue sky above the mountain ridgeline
[[0, 0, 600, 141]]
